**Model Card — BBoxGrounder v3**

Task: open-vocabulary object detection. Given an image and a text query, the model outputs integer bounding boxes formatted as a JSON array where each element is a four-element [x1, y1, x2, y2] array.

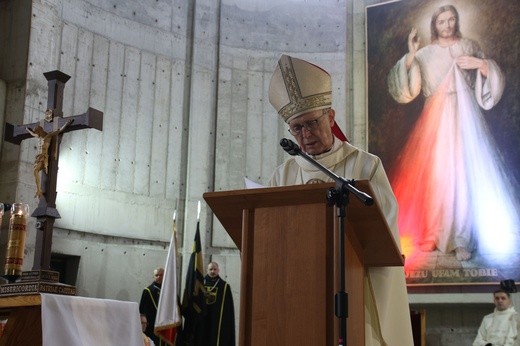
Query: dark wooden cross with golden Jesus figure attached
[[5, 70, 103, 270]]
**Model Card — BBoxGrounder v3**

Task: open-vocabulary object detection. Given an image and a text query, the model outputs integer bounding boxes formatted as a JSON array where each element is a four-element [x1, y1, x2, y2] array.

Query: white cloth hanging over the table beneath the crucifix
[[41, 294, 143, 346]]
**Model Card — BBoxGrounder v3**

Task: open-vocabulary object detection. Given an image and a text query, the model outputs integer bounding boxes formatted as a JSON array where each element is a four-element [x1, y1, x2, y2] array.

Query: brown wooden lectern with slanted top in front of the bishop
[[204, 181, 404, 346]]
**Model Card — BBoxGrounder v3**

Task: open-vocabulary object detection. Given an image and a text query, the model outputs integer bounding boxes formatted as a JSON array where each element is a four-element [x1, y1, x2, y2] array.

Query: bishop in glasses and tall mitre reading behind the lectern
[[269, 55, 413, 346]]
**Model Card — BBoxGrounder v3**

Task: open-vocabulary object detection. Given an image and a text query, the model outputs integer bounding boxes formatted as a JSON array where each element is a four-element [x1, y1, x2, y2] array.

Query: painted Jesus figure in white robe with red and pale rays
[[387, 5, 519, 261]]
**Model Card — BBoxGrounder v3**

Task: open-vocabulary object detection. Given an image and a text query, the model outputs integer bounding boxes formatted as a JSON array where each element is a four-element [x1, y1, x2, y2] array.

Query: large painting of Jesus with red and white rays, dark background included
[[366, 0, 520, 285]]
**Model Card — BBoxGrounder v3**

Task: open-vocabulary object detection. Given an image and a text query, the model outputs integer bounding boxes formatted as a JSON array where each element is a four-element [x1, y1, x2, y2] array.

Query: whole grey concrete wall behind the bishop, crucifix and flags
[[0, 0, 504, 346]]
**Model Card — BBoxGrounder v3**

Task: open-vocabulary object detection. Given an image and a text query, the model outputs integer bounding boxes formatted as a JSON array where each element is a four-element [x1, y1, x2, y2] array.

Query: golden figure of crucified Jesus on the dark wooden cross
[[25, 115, 73, 198]]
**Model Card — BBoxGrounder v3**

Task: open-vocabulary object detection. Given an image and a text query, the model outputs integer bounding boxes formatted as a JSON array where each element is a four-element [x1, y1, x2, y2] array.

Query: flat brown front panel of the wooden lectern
[[240, 204, 334, 345]]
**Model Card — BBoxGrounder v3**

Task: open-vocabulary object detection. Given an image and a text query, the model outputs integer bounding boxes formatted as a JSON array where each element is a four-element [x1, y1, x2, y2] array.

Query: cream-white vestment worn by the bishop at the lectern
[[270, 139, 413, 346]]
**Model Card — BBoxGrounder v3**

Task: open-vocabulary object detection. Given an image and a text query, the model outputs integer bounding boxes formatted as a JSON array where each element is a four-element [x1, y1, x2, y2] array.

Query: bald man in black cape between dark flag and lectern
[[204, 262, 235, 346]]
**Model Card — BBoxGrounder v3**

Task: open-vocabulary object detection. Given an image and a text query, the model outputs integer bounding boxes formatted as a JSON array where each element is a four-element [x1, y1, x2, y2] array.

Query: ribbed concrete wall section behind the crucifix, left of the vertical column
[[1, 1, 194, 300]]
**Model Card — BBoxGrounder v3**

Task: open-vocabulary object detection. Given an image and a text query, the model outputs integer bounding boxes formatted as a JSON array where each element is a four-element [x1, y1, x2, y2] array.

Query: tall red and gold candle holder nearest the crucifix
[[4, 203, 29, 282]]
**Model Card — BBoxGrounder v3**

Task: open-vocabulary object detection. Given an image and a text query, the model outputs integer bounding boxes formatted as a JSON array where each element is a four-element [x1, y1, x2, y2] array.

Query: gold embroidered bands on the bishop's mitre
[[278, 59, 332, 122]]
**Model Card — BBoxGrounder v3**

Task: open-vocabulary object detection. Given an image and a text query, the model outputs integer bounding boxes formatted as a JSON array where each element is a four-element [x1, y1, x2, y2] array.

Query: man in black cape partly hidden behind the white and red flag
[[139, 268, 165, 346]]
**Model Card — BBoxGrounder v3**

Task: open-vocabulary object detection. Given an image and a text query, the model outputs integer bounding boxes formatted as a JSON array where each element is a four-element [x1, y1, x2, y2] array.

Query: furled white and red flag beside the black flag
[[154, 221, 181, 345]]
